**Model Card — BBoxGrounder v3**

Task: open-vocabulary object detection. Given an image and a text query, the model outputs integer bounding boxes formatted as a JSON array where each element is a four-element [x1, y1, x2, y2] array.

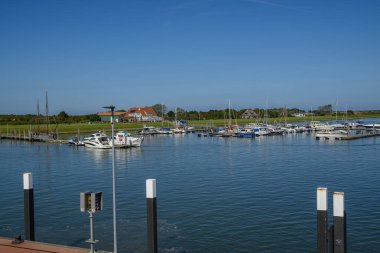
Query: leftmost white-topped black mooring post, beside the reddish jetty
[[23, 173, 35, 241]]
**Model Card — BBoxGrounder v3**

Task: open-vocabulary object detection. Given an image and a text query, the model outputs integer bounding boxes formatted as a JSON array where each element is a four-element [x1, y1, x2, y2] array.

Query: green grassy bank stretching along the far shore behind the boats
[[0, 114, 380, 137]]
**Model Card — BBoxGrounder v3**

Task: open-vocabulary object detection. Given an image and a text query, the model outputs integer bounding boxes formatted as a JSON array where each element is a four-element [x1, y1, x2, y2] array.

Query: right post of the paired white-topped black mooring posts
[[333, 192, 346, 253]]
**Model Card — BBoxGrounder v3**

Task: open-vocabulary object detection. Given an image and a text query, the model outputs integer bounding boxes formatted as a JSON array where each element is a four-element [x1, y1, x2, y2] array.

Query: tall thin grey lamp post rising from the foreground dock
[[103, 105, 117, 253]]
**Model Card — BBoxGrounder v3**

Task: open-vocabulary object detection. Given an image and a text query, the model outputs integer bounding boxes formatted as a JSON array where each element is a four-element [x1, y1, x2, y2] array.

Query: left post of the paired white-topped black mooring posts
[[317, 187, 328, 253]]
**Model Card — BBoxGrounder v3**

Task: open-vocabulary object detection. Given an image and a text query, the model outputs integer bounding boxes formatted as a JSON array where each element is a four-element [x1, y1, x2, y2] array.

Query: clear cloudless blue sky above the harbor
[[0, 0, 380, 115]]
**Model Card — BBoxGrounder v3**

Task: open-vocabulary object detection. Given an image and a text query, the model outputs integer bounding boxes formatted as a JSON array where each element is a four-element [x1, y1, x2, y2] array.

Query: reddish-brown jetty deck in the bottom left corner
[[0, 237, 109, 253]]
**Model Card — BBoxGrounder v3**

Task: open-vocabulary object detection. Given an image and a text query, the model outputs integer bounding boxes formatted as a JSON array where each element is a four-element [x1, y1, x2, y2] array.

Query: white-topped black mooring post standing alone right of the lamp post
[[146, 179, 158, 253]]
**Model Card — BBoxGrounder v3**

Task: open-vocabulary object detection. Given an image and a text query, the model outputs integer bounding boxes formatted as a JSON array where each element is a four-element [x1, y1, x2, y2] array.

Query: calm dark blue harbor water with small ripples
[[0, 121, 380, 253]]
